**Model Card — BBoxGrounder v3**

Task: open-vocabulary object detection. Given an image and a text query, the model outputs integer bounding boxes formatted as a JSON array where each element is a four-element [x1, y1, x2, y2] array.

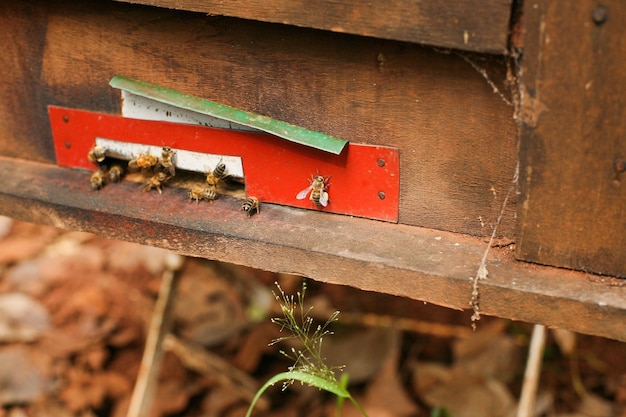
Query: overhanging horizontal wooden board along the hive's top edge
[[118, 0, 512, 54]]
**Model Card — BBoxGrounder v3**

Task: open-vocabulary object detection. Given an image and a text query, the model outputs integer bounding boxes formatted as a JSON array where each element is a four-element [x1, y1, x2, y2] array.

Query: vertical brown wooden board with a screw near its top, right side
[[517, 0, 626, 277]]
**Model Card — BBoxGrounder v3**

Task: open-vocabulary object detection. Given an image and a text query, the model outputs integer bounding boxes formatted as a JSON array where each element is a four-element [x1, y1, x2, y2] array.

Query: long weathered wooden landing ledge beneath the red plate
[[0, 157, 626, 341]]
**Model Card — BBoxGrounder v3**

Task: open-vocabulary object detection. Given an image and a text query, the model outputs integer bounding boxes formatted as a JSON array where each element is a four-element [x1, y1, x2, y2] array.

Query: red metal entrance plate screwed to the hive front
[[48, 106, 400, 222]]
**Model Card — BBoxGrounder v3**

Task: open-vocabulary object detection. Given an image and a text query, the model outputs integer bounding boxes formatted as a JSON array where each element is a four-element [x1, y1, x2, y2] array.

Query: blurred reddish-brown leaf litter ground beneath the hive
[[0, 218, 626, 417]]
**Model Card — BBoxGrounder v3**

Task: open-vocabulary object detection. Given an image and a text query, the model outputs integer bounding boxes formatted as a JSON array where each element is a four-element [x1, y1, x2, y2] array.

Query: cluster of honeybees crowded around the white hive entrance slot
[[87, 144, 260, 217]]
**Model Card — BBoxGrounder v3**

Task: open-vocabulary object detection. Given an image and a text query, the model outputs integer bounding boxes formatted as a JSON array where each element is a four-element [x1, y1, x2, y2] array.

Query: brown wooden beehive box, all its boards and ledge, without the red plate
[[0, 0, 626, 340]]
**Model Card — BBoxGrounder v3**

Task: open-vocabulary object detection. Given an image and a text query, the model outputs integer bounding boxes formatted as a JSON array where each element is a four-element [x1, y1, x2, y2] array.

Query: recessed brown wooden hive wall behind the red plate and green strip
[[0, 0, 517, 237]]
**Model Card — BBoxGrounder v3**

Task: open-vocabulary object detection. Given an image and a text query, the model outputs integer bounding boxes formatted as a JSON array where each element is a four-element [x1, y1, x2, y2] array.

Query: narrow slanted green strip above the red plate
[[109, 75, 348, 155]]
